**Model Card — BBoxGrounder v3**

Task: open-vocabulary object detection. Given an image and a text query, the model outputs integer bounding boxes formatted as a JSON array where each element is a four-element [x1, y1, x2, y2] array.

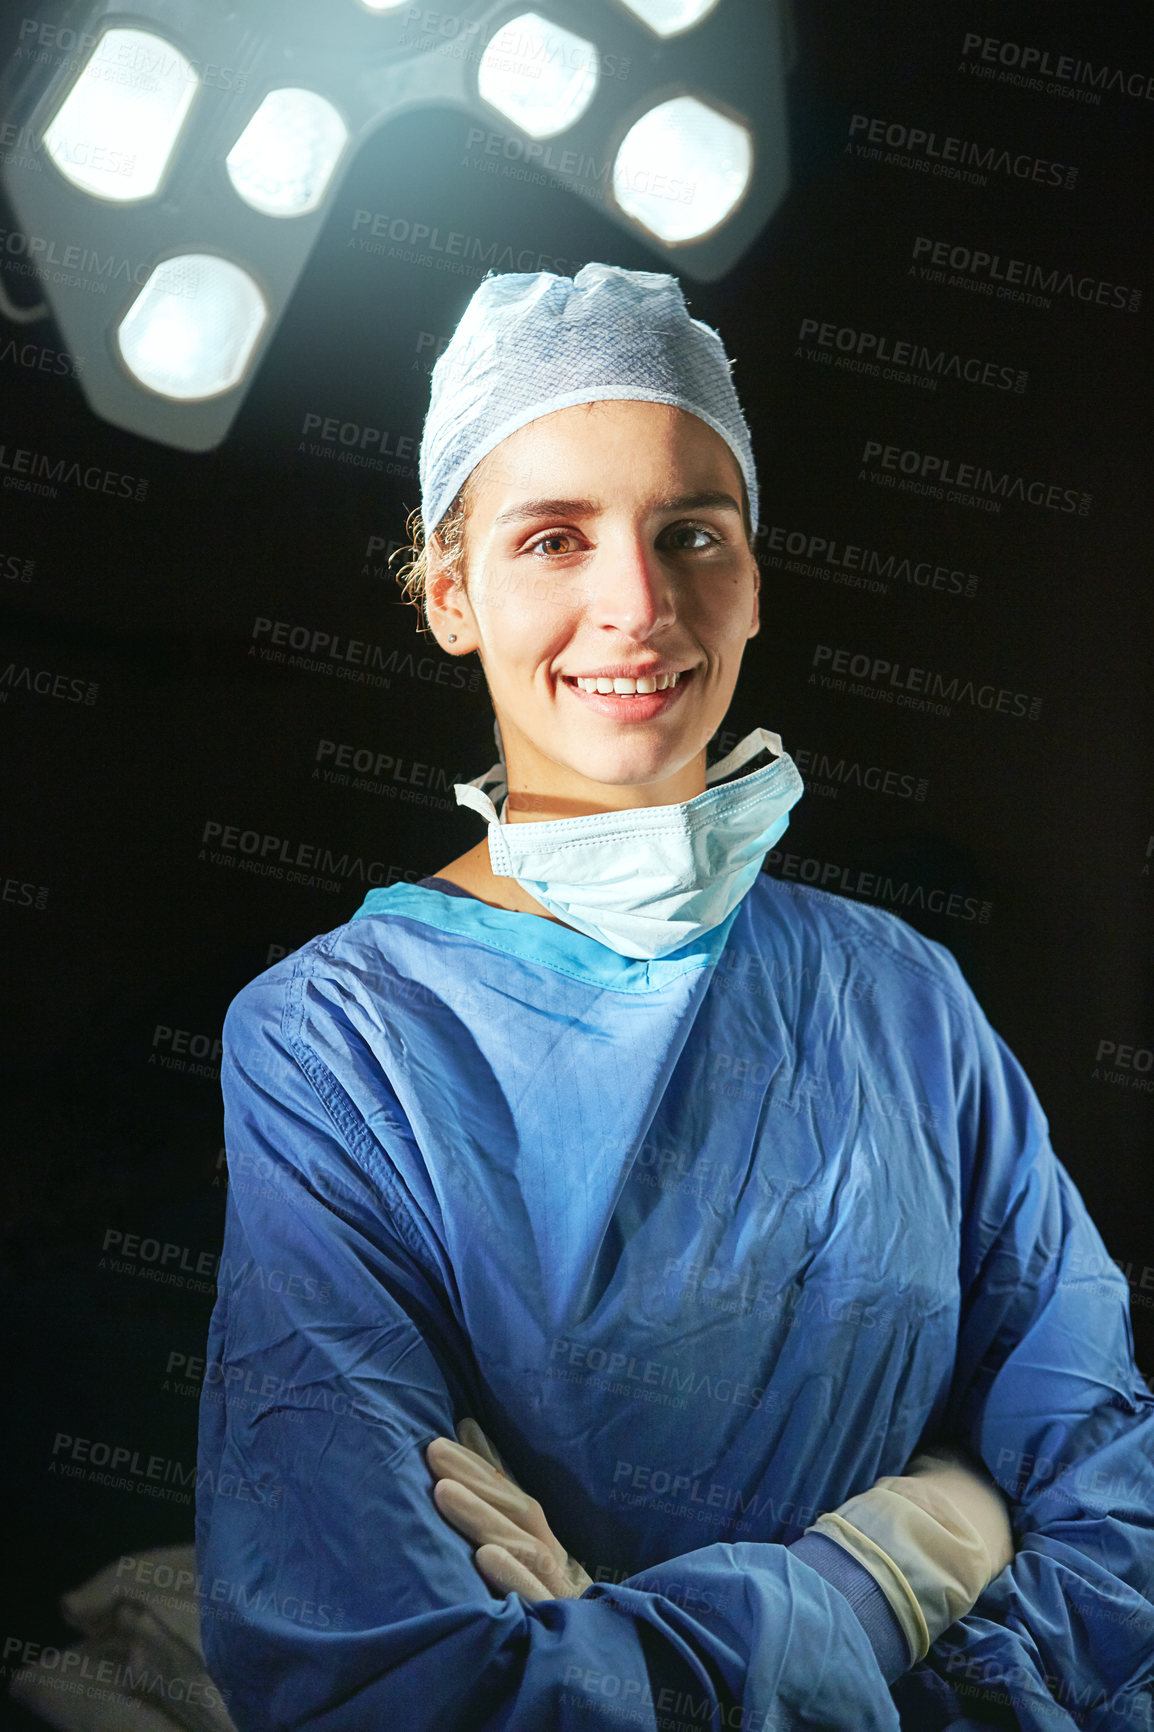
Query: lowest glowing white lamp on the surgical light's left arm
[[116, 253, 269, 402]]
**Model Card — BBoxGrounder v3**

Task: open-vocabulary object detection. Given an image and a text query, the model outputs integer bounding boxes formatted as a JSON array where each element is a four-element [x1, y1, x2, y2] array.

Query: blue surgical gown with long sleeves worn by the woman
[[198, 876, 1154, 1732]]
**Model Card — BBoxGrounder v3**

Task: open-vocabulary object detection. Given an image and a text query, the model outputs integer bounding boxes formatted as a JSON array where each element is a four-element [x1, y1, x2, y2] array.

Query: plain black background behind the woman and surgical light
[[0, 0, 1154, 1704]]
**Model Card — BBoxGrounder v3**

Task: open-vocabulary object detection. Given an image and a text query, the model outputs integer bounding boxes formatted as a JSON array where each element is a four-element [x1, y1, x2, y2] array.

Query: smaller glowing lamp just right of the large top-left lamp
[[225, 88, 348, 217]]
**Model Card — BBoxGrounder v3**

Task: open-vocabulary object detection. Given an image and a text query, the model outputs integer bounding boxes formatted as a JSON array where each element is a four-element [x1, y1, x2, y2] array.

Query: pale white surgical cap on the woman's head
[[419, 263, 757, 535]]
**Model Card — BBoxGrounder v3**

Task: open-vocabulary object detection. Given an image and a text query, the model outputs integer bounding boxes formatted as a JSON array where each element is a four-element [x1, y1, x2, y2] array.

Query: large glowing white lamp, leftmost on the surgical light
[[43, 29, 199, 204]]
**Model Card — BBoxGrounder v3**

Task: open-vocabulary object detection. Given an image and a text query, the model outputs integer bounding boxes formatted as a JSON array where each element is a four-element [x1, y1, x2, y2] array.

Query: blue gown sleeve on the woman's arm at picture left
[[198, 970, 899, 1732]]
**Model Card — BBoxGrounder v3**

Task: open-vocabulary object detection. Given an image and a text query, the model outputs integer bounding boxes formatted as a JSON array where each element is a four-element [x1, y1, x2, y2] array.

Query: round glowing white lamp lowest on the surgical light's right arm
[[613, 97, 754, 246]]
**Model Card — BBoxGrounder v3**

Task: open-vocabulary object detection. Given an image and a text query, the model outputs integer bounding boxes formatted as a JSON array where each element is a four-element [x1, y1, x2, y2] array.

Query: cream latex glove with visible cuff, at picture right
[[807, 1446, 1014, 1661]]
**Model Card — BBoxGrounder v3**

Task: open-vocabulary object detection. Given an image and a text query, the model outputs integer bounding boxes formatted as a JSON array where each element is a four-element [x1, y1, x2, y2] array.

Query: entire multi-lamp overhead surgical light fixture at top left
[[0, 0, 790, 450]]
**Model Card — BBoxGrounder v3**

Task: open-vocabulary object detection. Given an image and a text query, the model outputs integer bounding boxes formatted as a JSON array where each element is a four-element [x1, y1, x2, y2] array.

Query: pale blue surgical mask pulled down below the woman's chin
[[454, 727, 804, 961]]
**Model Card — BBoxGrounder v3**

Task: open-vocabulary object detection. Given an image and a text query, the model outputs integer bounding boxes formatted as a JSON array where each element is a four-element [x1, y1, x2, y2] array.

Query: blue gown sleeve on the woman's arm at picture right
[[894, 958, 1154, 1732]]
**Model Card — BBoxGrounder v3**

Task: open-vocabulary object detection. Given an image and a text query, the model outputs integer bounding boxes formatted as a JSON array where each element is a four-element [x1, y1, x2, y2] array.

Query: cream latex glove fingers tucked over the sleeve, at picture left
[[425, 1419, 593, 1600]]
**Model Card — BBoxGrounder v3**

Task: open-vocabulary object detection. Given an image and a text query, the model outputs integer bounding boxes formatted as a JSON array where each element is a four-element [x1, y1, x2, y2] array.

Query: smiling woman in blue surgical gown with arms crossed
[[198, 265, 1154, 1732]]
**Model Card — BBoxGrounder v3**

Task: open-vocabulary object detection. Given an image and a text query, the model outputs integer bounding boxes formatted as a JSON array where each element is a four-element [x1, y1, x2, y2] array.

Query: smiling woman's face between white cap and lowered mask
[[428, 402, 757, 818]]
